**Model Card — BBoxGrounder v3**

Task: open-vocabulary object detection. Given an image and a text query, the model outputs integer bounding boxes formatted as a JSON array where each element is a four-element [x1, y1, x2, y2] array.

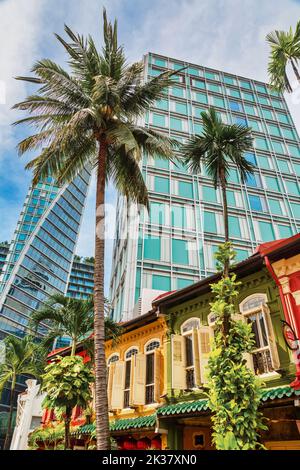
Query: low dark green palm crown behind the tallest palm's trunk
[[30, 294, 122, 356]]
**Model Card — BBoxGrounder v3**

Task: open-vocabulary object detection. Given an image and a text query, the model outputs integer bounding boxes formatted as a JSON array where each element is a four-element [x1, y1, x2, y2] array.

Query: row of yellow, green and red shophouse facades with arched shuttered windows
[[40, 235, 300, 450]]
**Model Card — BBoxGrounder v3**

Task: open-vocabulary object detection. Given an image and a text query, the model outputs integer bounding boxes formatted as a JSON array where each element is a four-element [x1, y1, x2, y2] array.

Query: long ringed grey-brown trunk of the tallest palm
[[94, 136, 110, 450]]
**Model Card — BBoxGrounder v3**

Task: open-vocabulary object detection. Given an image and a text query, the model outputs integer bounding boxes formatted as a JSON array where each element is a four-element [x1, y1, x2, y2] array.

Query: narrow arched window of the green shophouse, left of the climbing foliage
[[181, 318, 200, 390]]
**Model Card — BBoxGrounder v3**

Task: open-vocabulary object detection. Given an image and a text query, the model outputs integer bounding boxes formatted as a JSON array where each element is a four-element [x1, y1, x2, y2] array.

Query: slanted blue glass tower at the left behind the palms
[[0, 170, 90, 339]]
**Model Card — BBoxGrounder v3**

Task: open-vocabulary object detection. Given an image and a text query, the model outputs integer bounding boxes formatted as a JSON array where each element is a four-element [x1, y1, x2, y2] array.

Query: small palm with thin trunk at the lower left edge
[[0, 336, 46, 449]]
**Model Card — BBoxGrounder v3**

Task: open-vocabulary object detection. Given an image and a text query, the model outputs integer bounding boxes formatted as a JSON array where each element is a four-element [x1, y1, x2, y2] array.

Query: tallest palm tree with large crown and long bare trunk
[[15, 10, 176, 450]]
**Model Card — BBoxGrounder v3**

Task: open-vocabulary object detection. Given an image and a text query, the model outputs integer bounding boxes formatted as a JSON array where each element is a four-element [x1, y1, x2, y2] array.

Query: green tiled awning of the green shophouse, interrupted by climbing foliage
[[157, 386, 300, 416]]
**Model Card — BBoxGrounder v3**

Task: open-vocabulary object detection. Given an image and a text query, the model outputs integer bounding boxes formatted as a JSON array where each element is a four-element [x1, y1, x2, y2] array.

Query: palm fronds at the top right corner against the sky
[[266, 21, 300, 93]]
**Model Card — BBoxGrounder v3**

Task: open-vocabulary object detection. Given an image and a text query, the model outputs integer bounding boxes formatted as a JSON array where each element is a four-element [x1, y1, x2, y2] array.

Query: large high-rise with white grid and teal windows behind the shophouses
[[110, 53, 300, 320]]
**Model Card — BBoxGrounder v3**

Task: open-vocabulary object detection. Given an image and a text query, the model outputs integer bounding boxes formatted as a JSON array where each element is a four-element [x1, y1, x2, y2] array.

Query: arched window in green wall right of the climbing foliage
[[240, 294, 280, 375]]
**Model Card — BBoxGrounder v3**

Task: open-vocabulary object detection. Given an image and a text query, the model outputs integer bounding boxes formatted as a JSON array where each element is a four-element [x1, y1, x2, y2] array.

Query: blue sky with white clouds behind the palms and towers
[[0, 0, 300, 292]]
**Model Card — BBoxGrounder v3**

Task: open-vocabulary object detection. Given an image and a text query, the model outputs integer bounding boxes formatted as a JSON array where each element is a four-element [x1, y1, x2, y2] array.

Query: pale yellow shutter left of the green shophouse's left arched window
[[172, 335, 186, 390]]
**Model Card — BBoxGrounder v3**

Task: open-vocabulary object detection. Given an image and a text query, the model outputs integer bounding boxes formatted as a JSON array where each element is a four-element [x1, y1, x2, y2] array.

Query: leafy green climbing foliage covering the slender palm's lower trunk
[[208, 243, 266, 450]]
